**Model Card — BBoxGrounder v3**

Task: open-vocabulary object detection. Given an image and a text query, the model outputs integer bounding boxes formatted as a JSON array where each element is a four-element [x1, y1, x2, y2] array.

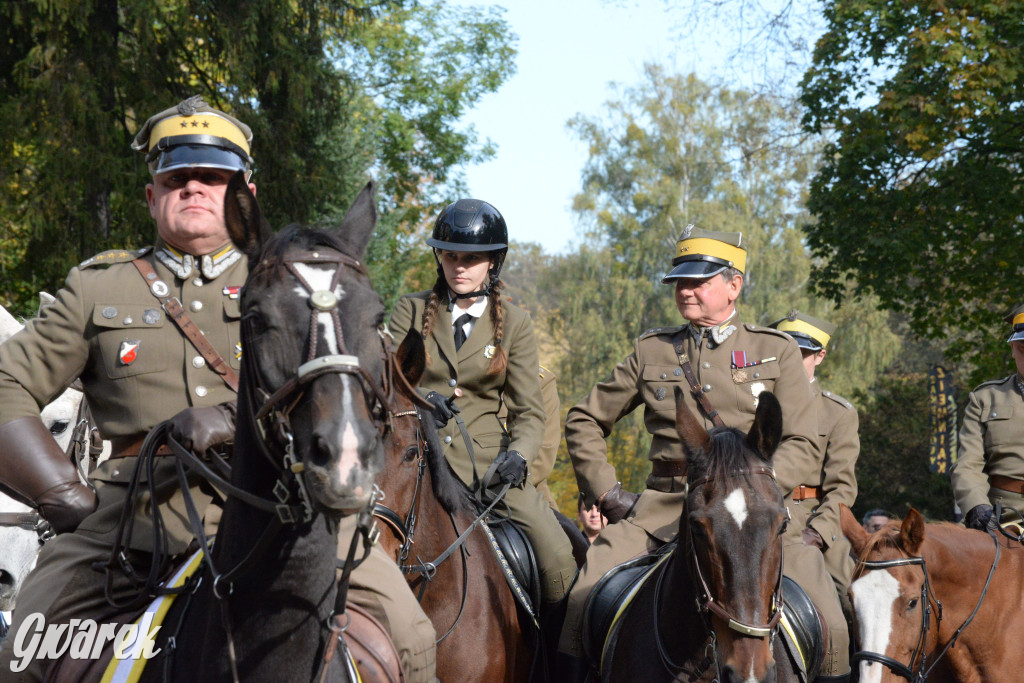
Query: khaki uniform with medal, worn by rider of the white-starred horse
[[559, 316, 849, 673]]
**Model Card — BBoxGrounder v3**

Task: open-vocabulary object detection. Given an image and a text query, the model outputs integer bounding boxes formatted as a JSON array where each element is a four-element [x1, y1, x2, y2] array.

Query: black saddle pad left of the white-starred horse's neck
[[582, 544, 675, 668]]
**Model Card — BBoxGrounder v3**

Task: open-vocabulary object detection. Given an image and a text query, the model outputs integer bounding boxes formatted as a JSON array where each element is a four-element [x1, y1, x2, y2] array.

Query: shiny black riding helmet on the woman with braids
[[427, 199, 509, 299]]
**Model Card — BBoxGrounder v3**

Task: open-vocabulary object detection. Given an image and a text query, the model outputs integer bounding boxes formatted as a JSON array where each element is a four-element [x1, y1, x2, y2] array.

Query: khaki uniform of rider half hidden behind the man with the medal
[[806, 381, 860, 614]]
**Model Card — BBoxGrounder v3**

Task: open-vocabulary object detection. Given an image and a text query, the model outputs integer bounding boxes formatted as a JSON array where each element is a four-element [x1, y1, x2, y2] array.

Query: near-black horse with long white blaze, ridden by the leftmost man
[[46, 173, 411, 683]]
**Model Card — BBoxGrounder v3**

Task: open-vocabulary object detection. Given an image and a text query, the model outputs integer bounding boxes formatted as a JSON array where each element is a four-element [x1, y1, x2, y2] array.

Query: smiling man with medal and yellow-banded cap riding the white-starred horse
[[558, 226, 849, 674]]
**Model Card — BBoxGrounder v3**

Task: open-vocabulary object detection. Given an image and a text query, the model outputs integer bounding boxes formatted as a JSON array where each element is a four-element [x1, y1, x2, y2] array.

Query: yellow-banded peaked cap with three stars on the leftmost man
[[132, 95, 253, 175]]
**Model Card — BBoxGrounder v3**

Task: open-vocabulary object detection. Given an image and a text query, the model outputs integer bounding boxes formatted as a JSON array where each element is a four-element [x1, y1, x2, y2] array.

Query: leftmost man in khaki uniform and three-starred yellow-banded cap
[[0, 96, 255, 680]]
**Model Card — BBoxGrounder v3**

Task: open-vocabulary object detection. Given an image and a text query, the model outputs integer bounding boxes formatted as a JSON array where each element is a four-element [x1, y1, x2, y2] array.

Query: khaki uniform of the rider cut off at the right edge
[[949, 373, 1024, 519]]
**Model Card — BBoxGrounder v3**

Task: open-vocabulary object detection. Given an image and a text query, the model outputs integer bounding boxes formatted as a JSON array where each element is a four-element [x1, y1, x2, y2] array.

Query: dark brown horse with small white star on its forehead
[[601, 390, 813, 683]]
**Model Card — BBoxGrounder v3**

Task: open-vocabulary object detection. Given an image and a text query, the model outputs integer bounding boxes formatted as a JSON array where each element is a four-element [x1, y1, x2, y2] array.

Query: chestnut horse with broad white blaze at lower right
[[840, 506, 1024, 683]]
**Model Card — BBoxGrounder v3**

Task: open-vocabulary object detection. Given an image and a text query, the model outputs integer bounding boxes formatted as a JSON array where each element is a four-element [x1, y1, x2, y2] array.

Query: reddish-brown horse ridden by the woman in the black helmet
[[377, 333, 532, 683]]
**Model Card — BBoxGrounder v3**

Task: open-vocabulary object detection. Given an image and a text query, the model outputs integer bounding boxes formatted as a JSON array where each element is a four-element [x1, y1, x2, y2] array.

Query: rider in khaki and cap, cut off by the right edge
[[949, 304, 1024, 529]]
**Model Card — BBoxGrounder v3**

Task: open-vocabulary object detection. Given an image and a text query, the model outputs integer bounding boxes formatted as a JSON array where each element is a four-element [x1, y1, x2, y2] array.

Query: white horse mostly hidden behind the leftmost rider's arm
[[0, 292, 110, 611]]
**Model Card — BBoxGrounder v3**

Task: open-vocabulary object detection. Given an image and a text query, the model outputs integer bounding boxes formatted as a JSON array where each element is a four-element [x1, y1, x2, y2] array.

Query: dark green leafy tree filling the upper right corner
[[801, 0, 1024, 380]]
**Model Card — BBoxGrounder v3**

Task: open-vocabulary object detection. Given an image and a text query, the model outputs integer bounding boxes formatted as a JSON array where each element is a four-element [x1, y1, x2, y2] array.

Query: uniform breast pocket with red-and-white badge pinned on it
[[92, 302, 171, 379]]
